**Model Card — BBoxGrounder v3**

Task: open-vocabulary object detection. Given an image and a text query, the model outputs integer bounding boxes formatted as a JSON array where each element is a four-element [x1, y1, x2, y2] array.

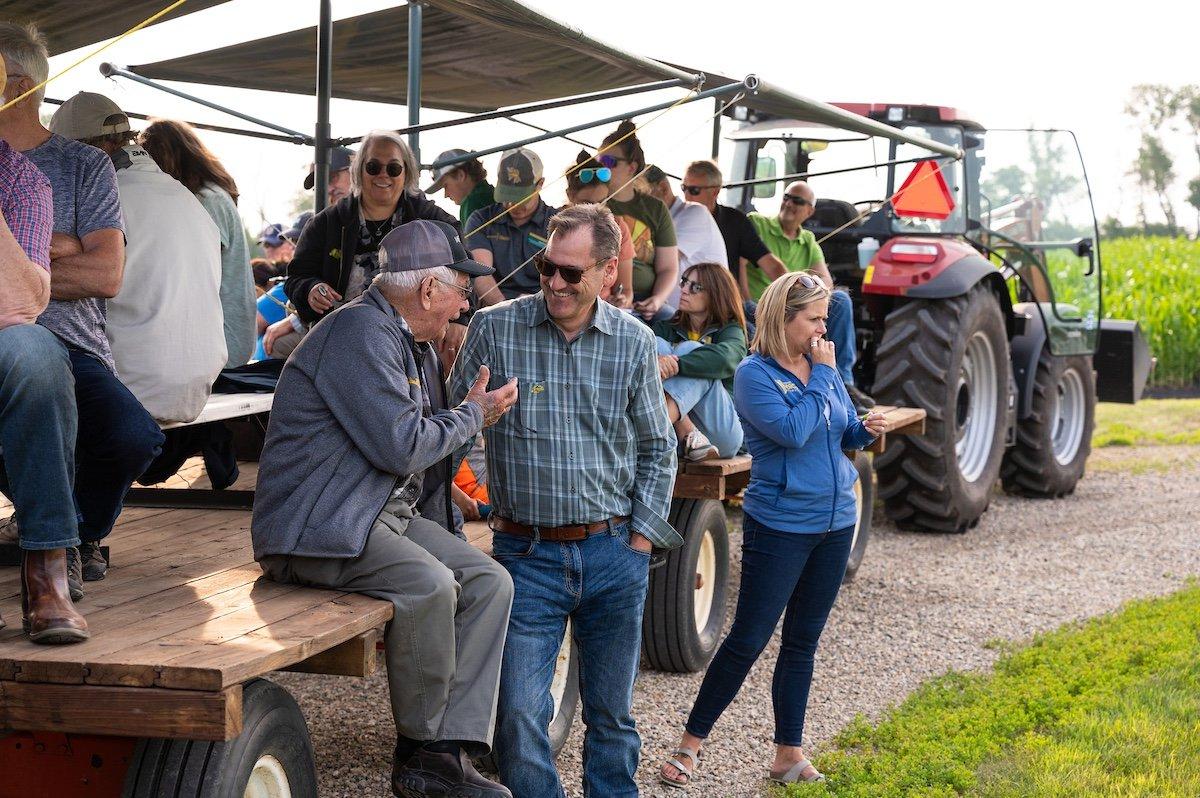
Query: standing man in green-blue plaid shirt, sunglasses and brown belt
[[450, 205, 683, 798]]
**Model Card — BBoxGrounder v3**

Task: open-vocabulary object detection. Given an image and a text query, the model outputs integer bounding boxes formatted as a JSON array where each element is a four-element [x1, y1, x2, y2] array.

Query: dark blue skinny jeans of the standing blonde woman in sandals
[[685, 515, 854, 745]]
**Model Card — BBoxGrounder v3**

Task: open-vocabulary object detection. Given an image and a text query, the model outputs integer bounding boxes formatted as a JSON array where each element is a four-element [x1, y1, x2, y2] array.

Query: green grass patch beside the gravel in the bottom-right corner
[[786, 584, 1200, 798]]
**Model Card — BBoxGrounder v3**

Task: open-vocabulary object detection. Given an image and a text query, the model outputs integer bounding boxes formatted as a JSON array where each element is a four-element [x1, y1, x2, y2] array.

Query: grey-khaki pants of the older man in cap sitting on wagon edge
[[260, 503, 512, 755]]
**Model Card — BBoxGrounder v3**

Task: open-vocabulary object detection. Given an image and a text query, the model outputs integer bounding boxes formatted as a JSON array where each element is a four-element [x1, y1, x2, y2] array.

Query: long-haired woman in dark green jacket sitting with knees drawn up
[[653, 263, 746, 462]]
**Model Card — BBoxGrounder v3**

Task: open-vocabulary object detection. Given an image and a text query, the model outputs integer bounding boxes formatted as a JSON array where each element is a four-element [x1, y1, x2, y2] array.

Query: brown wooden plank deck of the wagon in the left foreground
[[0, 464, 391, 739]]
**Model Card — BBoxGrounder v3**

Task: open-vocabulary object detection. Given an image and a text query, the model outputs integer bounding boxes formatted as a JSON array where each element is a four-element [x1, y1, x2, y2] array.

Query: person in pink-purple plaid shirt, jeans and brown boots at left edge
[[0, 99, 88, 643]]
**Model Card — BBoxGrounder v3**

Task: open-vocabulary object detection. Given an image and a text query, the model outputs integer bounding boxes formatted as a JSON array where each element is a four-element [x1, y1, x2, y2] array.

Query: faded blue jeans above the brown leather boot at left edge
[[0, 324, 79, 550]]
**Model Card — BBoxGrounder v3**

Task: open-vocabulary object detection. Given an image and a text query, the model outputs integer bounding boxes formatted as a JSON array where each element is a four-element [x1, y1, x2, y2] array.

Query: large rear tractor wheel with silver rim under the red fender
[[872, 283, 1012, 532]]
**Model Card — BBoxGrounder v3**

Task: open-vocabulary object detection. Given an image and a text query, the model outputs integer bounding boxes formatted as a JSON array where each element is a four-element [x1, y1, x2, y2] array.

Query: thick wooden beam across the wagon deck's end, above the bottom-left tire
[[0, 682, 241, 740]]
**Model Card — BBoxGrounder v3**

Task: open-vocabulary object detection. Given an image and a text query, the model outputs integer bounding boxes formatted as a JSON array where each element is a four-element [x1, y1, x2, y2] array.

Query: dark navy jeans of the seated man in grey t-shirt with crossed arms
[[66, 347, 164, 542]]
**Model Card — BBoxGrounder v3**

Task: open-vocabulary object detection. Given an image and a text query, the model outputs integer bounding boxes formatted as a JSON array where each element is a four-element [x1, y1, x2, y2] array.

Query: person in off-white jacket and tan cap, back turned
[[50, 91, 227, 422]]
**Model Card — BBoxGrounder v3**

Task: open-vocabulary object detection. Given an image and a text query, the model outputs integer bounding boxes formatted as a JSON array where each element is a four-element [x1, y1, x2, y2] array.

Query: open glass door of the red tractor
[[972, 130, 1100, 355]]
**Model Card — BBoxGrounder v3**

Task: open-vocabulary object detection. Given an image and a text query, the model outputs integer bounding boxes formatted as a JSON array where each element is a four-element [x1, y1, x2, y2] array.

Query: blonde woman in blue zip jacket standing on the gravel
[[660, 271, 883, 787]]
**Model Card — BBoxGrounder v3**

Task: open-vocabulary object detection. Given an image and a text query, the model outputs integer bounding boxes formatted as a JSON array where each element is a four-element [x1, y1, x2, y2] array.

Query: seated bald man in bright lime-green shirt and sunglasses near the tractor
[[745, 180, 875, 412]]
